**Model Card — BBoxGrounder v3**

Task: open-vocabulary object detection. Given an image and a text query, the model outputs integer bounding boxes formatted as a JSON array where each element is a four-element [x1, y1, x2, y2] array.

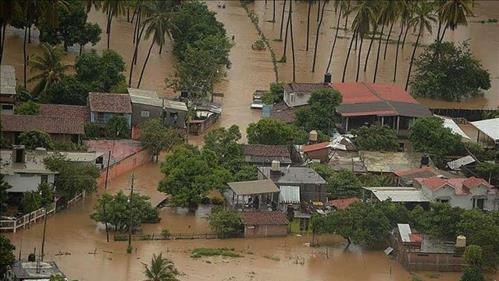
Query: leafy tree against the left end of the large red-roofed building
[[296, 88, 342, 134]]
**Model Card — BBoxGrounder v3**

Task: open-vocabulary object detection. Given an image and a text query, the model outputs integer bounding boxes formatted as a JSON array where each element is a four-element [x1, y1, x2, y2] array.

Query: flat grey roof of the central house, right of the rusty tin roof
[[258, 167, 326, 185]]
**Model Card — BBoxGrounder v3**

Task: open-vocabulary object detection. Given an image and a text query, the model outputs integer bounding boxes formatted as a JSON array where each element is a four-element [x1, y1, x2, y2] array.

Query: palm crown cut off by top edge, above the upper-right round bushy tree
[[438, 0, 474, 42]]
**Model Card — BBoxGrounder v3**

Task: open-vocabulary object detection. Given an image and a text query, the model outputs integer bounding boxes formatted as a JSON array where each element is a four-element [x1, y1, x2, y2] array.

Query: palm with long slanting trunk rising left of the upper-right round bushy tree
[[405, 1, 437, 91]]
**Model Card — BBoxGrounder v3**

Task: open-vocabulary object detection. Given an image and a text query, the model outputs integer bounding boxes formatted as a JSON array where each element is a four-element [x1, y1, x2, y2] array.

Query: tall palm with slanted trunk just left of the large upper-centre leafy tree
[[137, 1, 173, 88]]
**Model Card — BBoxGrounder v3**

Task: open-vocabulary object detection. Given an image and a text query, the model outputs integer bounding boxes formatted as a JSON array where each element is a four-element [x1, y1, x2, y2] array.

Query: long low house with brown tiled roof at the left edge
[[1, 104, 88, 144]]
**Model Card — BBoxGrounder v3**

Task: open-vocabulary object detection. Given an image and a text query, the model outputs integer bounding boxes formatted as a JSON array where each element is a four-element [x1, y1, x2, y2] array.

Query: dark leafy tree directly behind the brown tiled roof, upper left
[[75, 50, 126, 93]]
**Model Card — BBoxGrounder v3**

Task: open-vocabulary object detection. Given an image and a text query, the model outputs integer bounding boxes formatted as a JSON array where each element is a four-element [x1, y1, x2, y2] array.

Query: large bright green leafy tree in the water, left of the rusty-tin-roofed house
[[158, 145, 232, 210]]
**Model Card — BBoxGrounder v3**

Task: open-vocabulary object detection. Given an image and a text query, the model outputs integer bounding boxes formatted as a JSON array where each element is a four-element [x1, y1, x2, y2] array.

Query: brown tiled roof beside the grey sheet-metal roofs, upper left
[[88, 93, 132, 113]]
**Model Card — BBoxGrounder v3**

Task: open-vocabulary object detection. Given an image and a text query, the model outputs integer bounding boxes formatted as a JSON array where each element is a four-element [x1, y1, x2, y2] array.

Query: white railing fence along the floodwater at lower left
[[0, 192, 85, 233]]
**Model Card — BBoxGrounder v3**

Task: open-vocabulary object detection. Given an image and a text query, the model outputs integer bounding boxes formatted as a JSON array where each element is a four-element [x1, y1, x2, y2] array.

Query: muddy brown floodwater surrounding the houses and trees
[[5, 1, 499, 281]]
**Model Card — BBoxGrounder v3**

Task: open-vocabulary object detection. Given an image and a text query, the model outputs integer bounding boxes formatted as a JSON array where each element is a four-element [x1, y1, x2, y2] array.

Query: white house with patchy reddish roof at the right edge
[[414, 176, 499, 211]]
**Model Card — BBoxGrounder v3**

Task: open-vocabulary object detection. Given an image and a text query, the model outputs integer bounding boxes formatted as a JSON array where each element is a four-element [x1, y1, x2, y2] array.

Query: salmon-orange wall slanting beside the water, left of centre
[[97, 149, 152, 186]]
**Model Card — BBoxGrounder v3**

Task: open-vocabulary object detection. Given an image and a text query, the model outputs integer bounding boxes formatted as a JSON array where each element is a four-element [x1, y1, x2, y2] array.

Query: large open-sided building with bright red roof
[[332, 82, 431, 135]]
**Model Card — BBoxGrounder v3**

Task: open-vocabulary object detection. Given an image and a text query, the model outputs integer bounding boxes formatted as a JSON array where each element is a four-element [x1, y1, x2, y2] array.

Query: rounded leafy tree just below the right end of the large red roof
[[409, 117, 463, 165]]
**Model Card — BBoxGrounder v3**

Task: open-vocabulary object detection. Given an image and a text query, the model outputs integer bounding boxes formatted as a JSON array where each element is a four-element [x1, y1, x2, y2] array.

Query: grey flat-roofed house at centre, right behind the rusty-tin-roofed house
[[258, 161, 327, 203]]
